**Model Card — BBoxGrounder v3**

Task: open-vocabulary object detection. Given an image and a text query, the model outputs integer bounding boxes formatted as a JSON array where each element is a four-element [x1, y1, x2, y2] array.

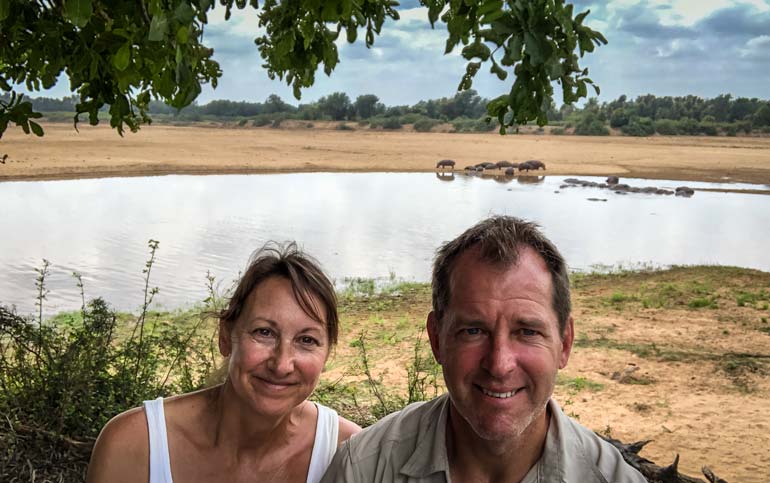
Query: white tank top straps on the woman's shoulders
[[144, 397, 339, 483]]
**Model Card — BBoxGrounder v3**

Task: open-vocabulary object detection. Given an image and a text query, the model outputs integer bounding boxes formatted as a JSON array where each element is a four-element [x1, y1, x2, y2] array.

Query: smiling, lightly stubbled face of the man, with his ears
[[428, 247, 573, 441]]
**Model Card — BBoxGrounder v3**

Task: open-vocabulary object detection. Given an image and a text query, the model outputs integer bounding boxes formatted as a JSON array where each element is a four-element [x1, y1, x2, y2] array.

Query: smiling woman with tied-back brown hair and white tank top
[[87, 243, 361, 483]]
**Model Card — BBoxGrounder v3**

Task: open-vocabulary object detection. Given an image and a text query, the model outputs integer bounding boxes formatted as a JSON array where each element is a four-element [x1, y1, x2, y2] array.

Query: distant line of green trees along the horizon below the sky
[[10, 90, 770, 136]]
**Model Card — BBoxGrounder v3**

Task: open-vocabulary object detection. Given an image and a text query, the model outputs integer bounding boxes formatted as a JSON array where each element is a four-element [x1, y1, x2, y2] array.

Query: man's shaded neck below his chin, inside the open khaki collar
[[446, 403, 550, 483]]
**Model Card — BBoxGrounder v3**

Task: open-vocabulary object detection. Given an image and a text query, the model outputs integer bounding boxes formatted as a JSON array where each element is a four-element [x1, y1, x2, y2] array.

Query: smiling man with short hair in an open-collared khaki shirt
[[322, 216, 646, 483]]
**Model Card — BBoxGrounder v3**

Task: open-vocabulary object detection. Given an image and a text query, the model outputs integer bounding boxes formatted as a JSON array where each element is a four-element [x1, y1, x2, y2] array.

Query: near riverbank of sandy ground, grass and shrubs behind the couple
[[0, 258, 770, 482]]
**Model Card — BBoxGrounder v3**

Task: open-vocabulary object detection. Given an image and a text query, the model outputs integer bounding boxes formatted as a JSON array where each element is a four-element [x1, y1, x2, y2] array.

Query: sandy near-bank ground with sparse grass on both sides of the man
[[330, 267, 770, 483]]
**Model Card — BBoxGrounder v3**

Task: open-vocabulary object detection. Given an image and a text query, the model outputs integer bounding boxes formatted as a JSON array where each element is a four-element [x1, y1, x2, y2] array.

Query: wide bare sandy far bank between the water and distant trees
[[0, 122, 770, 184]]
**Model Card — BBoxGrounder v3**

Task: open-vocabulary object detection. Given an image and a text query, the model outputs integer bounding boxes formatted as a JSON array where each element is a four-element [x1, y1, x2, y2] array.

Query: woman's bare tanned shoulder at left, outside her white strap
[[87, 407, 150, 483]]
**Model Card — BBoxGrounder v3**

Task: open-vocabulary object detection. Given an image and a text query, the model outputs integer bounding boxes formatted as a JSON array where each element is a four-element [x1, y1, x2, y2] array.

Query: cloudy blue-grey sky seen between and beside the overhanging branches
[[22, 0, 770, 105]]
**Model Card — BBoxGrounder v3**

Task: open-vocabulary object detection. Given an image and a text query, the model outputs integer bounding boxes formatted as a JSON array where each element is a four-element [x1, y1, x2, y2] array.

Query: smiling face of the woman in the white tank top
[[219, 276, 329, 417]]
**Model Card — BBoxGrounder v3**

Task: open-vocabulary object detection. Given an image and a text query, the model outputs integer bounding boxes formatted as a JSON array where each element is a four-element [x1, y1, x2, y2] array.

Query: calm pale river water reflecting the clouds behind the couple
[[0, 173, 770, 313]]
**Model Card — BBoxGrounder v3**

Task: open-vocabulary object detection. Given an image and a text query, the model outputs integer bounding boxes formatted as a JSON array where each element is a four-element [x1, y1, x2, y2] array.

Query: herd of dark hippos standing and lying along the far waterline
[[436, 159, 695, 197]]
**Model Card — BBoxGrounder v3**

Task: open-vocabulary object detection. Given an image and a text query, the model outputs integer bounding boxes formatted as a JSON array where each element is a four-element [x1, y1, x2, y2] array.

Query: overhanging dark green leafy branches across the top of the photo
[[0, 0, 607, 142]]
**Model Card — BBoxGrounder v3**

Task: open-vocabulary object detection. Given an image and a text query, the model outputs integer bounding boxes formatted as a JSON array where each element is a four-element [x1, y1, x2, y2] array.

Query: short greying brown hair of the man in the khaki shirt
[[433, 216, 572, 335]]
